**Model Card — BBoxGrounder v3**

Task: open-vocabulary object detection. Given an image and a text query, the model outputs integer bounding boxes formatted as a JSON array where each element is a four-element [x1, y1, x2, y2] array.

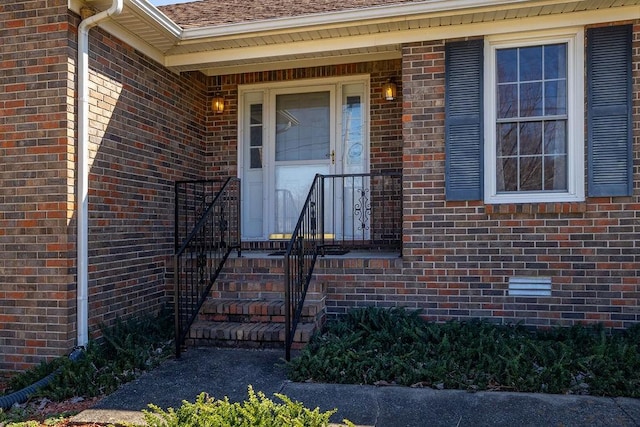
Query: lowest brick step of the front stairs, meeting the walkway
[[189, 321, 316, 343]]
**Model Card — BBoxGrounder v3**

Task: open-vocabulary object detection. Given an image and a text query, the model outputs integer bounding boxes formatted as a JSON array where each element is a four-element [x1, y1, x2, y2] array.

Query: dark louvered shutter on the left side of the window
[[445, 40, 483, 200]]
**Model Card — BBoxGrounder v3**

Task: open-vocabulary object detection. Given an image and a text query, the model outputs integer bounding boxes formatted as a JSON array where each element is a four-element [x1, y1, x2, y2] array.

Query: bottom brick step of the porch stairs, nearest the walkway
[[187, 320, 316, 348]]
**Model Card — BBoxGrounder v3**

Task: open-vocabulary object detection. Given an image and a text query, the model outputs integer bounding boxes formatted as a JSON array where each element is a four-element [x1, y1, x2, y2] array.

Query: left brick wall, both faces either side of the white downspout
[[0, 0, 207, 371]]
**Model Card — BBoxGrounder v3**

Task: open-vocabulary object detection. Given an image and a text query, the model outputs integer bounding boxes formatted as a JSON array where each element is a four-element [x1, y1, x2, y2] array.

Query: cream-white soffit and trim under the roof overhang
[[69, 0, 640, 75]]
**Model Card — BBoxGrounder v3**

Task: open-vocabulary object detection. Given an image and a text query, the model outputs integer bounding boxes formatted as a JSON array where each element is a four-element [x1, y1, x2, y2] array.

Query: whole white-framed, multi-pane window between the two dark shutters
[[485, 31, 584, 203]]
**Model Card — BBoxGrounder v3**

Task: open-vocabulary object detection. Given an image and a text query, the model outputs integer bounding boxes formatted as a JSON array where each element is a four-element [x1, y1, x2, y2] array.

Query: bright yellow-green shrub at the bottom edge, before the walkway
[[143, 386, 353, 427]]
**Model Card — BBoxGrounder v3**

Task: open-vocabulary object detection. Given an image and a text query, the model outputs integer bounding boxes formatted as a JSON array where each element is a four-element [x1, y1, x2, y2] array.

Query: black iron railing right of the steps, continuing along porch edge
[[284, 172, 402, 360]]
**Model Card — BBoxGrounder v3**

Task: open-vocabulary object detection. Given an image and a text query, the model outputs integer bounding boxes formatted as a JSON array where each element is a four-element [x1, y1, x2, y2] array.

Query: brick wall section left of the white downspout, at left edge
[[0, 0, 75, 371]]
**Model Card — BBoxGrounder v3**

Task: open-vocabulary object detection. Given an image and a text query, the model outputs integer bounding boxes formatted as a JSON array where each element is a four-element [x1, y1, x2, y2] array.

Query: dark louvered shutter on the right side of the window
[[587, 25, 633, 197]]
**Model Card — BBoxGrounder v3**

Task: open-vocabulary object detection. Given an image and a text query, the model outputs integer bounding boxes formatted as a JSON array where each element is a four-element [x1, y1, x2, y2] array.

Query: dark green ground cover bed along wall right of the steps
[[288, 308, 640, 397]]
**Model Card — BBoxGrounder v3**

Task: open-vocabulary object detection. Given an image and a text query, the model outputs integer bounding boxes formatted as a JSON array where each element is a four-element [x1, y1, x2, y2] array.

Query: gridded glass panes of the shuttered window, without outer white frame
[[496, 43, 567, 193]]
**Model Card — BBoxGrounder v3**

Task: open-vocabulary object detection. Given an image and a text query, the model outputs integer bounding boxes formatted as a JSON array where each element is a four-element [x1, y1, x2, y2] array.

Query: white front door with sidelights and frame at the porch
[[238, 76, 369, 240]]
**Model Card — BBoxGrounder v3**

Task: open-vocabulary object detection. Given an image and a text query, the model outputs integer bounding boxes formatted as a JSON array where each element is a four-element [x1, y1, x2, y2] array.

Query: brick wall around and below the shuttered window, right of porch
[[403, 24, 640, 327]]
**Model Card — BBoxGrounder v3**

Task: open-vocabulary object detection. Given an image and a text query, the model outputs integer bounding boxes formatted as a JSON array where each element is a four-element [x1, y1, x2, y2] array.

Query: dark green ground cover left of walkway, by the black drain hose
[[0, 312, 174, 426]]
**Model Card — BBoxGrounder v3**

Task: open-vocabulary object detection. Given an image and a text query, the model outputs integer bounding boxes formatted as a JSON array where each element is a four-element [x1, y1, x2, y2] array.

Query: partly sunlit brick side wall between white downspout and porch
[[83, 25, 209, 329]]
